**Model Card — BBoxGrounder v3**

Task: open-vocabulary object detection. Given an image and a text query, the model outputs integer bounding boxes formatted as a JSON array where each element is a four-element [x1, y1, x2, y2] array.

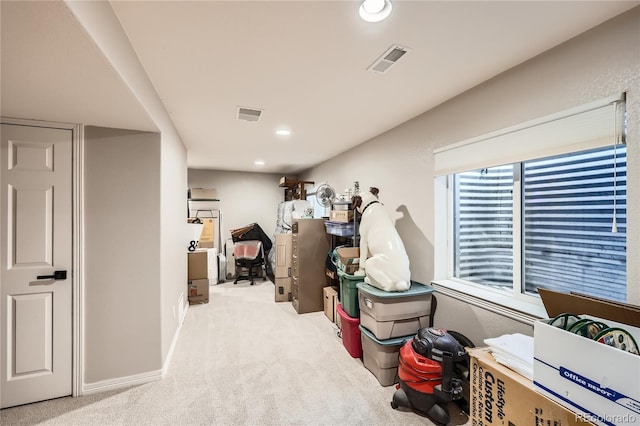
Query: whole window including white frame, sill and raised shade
[[434, 95, 637, 316]]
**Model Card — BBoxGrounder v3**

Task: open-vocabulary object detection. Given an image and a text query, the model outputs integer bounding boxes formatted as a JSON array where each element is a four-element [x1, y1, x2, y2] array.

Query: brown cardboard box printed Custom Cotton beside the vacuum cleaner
[[467, 348, 589, 426]]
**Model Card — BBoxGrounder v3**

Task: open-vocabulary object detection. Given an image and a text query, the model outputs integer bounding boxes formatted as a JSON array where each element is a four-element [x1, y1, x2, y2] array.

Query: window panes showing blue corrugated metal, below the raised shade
[[451, 145, 626, 301]]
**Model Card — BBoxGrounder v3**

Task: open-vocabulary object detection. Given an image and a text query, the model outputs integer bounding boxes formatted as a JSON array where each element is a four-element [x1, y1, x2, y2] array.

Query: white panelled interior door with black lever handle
[[0, 124, 72, 408]]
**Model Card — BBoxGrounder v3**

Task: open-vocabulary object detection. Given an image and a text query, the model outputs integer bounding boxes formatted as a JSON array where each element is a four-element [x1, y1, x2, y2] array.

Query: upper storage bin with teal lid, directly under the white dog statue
[[357, 282, 433, 340]]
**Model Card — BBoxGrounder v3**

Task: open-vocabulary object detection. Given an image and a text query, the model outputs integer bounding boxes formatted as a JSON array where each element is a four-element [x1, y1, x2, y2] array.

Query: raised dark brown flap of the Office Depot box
[[538, 288, 640, 327]]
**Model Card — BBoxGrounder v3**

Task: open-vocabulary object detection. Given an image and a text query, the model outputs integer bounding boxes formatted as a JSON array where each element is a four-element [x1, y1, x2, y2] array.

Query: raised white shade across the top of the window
[[434, 95, 624, 176]]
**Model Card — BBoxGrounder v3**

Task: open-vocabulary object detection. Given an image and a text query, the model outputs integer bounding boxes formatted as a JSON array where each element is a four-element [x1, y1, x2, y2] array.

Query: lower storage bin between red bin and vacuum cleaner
[[359, 324, 413, 386]]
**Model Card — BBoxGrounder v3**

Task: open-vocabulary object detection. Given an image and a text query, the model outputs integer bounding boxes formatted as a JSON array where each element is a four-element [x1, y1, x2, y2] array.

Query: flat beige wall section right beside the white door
[[83, 126, 162, 385]]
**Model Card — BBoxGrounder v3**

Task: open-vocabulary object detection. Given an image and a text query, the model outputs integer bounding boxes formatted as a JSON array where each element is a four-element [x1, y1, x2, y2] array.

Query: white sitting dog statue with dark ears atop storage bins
[[352, 188, 411, 291]]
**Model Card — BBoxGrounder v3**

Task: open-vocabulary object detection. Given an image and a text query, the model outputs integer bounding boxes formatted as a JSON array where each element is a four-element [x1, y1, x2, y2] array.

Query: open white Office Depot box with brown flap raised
[[533, 289, 640, 425]]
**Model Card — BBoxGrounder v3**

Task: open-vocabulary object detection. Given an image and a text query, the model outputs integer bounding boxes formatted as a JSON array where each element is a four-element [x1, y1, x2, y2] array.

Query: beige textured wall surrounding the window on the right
[[300, 8, 640, 343]]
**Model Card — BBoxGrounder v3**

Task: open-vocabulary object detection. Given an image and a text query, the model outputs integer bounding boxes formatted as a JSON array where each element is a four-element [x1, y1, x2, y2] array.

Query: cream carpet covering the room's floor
[[0, 280, 468, 426]]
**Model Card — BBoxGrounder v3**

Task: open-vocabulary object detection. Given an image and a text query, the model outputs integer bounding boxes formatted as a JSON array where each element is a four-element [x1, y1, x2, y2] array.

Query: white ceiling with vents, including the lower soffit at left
[[0, 0, 640, 173]]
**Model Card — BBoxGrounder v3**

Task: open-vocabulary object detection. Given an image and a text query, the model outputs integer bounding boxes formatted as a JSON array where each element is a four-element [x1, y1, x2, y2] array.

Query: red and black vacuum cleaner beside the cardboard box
[[391, 328, 469, 425]]
